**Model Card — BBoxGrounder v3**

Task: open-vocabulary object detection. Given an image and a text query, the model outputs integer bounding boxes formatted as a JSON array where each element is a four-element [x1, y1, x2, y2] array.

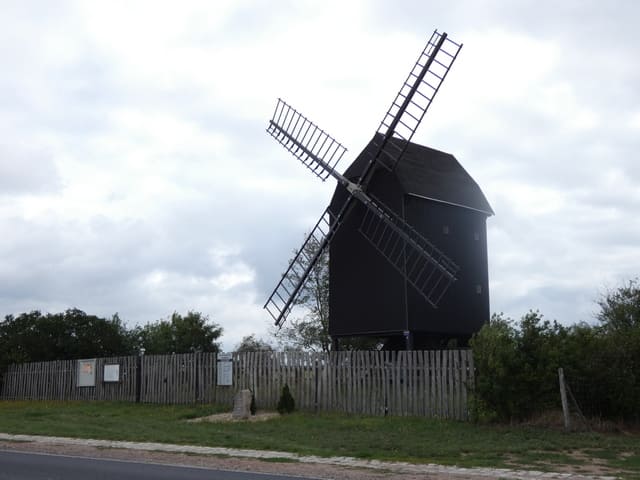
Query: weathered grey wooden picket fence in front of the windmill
[[0, 350, 474, 419]]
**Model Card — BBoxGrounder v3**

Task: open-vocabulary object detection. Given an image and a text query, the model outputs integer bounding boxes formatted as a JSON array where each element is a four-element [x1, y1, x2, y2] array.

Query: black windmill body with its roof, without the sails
[[329, 138, 493, 348]]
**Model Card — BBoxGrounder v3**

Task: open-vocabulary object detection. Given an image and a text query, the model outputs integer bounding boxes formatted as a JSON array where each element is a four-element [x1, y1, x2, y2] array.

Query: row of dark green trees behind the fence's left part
[[0, 309, 222, 371]]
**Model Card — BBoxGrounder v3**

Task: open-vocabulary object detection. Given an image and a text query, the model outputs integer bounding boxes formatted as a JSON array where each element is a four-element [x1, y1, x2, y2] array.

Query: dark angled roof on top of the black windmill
[[344, 134, 494, 215]]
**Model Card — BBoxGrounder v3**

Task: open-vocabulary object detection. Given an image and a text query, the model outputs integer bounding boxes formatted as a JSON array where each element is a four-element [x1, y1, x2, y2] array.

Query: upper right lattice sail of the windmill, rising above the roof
[[361, 30, 462, 174]]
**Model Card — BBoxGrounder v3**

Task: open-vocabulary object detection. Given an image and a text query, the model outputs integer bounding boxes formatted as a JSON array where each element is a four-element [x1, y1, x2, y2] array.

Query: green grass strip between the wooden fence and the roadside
[[0, 401, 640, 478]]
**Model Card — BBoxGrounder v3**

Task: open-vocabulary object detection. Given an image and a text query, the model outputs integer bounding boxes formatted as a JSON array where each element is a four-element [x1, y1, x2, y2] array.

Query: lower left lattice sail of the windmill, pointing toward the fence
[[264, 208, 338, 326]]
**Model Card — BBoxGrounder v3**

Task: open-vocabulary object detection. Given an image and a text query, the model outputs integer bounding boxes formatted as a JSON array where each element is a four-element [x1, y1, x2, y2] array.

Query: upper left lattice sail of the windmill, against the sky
[[267, 98, 347, 181]]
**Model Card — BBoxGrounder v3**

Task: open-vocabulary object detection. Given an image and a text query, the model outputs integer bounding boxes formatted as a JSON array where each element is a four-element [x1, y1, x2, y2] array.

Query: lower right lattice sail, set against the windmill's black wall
[[358, 195, 459, 307]]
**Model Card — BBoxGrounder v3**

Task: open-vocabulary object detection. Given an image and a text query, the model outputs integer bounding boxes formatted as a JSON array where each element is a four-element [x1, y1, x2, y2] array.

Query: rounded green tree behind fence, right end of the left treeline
[[135, 311, 222, 355]]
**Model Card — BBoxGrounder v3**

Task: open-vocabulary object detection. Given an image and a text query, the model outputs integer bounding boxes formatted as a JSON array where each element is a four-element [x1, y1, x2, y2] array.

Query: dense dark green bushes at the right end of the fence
[[471, 280, 640, 422]]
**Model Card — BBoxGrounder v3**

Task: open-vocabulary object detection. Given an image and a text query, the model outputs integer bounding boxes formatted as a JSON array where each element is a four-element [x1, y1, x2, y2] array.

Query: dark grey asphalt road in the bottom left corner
[[0, 450, 308, 480]]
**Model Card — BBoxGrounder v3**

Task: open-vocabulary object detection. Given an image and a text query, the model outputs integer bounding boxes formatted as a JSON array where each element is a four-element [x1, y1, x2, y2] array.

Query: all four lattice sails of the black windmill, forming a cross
[[265, 30, 490, 348]]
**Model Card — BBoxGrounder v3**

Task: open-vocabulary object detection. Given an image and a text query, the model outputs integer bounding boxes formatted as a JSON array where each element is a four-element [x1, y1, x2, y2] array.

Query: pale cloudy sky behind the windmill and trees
[[0, 0, 640, 350]]
